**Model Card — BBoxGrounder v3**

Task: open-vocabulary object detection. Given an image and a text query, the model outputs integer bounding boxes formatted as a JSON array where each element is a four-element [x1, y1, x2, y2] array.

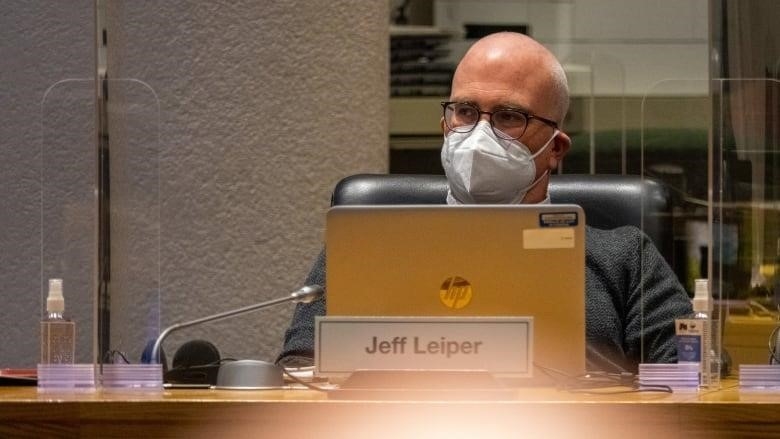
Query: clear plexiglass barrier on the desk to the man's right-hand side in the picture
[[636, 79, 780, 384]]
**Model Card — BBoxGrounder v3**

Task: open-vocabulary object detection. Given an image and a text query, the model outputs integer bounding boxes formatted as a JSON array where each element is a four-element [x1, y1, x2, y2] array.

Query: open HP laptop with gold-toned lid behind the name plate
[[326, 204, 585, 381]]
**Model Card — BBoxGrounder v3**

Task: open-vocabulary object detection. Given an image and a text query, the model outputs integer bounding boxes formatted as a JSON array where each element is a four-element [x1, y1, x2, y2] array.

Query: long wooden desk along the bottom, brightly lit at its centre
[[0, 380, 780, 439]]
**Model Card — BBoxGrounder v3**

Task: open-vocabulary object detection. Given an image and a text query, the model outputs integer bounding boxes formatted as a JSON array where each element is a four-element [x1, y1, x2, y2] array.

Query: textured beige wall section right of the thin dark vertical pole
[[107, 0, 388, 360]]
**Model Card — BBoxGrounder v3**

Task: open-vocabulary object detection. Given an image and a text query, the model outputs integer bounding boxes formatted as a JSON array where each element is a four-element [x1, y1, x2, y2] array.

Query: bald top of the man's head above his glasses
[[452, 32, 569, 124]]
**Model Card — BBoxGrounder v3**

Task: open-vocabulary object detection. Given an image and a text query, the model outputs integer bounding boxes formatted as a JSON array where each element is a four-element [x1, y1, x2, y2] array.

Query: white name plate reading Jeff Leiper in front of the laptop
[[314, 316, 533, 378]]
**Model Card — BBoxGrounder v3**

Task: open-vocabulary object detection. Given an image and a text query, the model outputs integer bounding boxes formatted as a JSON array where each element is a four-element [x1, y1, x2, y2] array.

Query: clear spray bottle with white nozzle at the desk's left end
[[41, 279, 76, 364]]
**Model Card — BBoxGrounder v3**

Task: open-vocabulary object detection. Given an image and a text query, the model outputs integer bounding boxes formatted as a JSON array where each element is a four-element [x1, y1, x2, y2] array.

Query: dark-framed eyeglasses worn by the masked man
[[441, 102, 558, 140]]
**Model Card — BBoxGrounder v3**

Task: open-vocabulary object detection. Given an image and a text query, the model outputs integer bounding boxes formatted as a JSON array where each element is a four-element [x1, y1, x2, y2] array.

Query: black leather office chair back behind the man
[[331, 174, 674, 264]]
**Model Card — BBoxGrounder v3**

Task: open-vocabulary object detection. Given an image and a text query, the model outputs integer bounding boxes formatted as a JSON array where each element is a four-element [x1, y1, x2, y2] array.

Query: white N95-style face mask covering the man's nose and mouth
[[441, 120, 558, 204]]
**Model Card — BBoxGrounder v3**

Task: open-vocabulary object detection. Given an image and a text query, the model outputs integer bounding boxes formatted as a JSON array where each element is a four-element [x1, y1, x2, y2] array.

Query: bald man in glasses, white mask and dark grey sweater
[[278, 32, 692, 372]]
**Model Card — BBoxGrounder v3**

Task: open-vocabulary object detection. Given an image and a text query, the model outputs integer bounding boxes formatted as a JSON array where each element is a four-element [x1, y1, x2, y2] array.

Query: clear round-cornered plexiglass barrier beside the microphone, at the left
[[40, 79, 160, 388]]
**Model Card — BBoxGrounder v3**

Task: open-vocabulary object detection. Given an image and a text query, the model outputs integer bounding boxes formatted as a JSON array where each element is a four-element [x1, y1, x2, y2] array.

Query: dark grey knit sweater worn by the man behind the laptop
[[277, 226, 692, 373]]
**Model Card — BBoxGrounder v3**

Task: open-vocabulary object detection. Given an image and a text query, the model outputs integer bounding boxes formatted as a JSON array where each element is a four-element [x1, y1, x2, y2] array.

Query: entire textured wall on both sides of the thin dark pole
[[0, 0, 388, 367]]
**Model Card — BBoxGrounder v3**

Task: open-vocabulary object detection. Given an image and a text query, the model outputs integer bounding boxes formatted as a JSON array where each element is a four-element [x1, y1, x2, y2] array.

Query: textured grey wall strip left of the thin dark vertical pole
[[0, 0, 96, 367]]
